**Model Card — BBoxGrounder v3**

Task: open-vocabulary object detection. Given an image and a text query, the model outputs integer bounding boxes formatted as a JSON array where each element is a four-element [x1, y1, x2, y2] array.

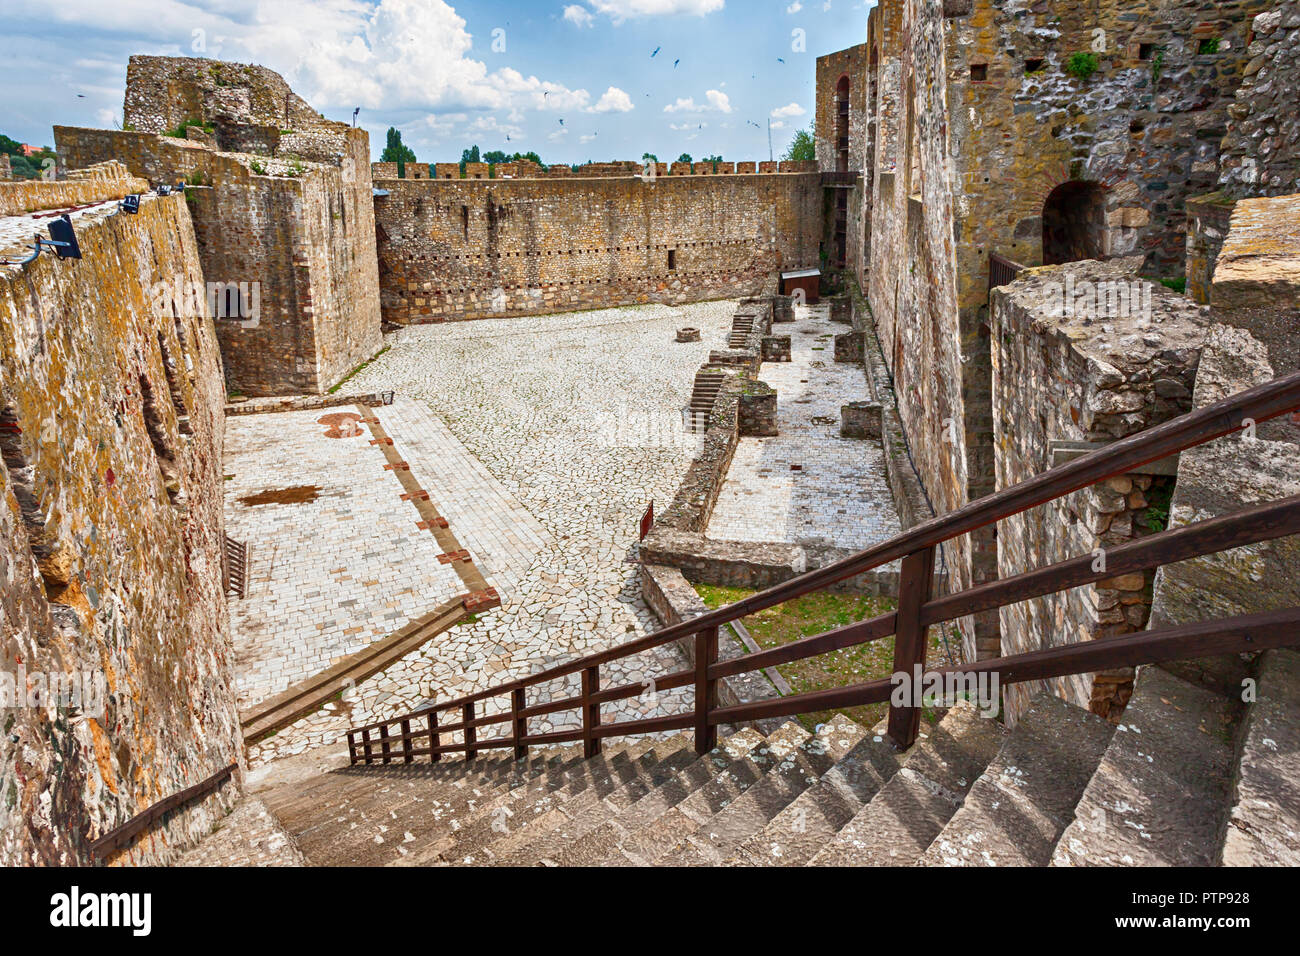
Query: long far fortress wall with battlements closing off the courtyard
[[374, 173, 822, 324]]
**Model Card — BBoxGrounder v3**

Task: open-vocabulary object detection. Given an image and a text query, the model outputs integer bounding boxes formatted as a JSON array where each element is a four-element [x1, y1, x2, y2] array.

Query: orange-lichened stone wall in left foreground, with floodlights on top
[[0, 186, 242, 865]]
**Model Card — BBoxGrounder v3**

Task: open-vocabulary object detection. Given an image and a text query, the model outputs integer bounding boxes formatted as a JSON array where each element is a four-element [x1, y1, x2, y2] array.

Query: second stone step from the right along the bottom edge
[[1052, 667, 1240, 866]]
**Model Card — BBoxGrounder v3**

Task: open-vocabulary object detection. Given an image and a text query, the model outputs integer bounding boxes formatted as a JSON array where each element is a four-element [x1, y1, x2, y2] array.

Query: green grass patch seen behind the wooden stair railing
[[696, 584, 943, 731]]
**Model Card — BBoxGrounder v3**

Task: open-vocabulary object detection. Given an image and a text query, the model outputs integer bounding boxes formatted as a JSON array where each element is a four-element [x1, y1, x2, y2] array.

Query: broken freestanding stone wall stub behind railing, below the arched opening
[[992, 259, 1209, 721]]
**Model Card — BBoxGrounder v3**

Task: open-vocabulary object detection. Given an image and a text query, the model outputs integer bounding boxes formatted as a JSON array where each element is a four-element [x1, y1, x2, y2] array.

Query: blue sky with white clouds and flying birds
[[0, 0, 874, 163]]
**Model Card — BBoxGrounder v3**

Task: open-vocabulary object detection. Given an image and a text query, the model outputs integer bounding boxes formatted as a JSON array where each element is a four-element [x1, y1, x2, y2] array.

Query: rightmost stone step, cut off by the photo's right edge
[[1222, 650, 1300, 866]]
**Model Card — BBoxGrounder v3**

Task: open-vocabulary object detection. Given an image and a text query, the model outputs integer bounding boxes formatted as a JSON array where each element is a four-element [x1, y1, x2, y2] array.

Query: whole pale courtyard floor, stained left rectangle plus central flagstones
[[236, 302, 736, 766]]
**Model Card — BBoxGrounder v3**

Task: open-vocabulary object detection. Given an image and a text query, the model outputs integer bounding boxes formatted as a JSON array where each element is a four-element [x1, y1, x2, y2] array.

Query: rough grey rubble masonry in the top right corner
[[1219, 3, 1300, 199]]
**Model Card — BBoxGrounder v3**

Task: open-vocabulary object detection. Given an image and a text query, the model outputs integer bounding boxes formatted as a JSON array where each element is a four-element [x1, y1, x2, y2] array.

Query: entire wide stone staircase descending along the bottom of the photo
[[233, 650, 1300, 866]]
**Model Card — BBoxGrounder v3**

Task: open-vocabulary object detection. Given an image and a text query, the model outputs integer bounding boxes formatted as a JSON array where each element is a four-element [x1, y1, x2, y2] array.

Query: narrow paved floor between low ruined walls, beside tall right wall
[[707, 306, 900, 549]]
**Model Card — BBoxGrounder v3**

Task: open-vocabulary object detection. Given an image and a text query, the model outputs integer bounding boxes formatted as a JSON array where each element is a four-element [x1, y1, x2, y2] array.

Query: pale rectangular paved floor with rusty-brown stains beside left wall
[[225, 406, 464, 708]]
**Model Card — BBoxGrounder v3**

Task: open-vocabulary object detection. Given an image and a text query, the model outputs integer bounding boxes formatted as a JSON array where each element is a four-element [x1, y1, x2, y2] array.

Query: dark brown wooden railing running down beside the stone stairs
[[347, 372, 1300, 763]]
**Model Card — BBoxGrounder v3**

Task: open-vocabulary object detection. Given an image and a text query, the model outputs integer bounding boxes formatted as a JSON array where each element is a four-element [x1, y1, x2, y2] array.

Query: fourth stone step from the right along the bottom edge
[[810, 701, 1005, 866]]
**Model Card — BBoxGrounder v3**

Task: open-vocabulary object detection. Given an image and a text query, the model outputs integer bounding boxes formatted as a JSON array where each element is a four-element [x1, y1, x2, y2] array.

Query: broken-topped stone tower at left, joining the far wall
[[55, 57, 382, 395]]
